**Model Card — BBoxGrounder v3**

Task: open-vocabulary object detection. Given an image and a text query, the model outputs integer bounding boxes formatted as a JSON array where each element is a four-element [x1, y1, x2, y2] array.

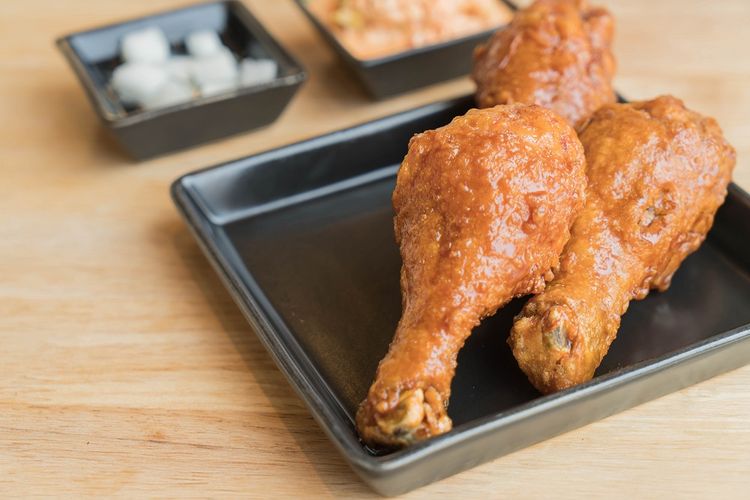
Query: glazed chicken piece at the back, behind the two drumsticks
[[472, 0, 615, 127]]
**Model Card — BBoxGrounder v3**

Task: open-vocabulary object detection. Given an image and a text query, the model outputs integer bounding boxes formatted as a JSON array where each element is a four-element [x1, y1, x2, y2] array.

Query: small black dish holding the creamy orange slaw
[[295, 0, 516, 99]]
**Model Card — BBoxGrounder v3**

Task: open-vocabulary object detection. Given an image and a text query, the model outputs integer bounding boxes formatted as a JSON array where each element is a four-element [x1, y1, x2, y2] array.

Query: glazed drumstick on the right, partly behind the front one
[[509, 97, 735, 393]]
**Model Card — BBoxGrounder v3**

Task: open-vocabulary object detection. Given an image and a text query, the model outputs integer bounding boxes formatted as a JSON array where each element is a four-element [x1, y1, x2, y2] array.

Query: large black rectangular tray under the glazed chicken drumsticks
[[172, 97, 750, 495]]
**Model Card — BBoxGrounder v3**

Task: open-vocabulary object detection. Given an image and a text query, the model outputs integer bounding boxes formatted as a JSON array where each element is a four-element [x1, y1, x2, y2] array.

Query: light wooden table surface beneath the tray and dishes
[[0, 0, 750, 498]]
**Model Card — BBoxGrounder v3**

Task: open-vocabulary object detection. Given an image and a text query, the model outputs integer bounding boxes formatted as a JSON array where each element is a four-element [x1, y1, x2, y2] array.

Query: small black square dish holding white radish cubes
[[57, 1, 306, 159]]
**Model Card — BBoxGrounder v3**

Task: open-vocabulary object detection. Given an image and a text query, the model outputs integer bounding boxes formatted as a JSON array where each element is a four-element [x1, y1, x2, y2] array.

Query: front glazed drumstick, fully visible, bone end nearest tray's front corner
[[357, 104, 586, 446]]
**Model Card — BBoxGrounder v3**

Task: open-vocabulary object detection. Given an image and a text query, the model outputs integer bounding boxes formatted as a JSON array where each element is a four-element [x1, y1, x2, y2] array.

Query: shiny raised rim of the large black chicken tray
[[170, 94, 750, 493]]
